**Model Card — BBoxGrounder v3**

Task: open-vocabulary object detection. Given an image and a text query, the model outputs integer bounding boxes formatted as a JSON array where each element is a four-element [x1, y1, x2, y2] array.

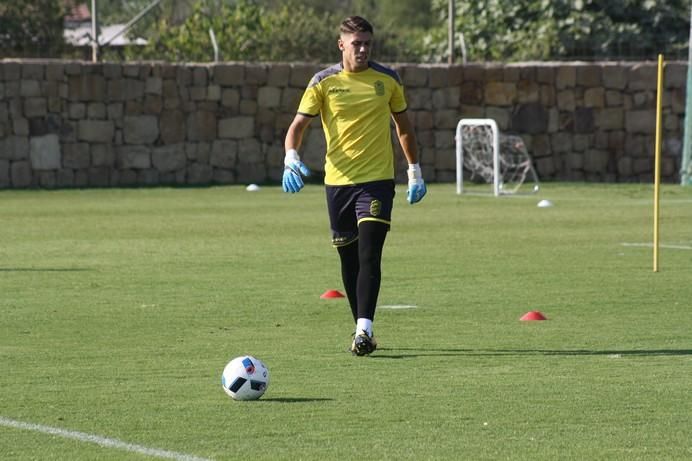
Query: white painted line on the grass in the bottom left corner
[[0, 416, 211, 461]]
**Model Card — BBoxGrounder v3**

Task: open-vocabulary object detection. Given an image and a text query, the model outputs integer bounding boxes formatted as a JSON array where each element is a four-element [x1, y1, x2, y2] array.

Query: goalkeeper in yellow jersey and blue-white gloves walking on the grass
[[283, 16, 426, 356]]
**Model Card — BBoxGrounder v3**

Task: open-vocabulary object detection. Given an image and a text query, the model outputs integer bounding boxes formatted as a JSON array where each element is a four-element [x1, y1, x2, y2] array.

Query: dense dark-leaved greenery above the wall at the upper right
[[425, 0, 689, 61]]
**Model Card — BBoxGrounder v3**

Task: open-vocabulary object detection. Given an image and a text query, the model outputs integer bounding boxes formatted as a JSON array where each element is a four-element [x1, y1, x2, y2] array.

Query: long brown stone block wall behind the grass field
[[0, 60, 687, 188]]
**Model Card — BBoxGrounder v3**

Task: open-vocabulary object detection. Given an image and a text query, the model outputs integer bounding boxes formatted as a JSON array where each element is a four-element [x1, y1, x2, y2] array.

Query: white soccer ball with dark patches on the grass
[[221, 355, 269, 400]]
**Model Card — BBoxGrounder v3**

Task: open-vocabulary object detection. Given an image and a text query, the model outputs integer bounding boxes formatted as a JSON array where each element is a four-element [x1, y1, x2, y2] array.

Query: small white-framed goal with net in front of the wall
[[456, 118, 539, 196]]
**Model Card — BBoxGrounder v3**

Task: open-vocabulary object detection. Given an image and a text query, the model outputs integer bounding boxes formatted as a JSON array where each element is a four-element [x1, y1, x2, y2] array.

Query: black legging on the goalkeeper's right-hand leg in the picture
[[356, 221, 389, 320]]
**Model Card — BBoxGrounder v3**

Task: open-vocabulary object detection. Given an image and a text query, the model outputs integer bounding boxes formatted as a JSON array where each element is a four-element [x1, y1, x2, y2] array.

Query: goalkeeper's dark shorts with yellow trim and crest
[[326, 179, 395, 247]]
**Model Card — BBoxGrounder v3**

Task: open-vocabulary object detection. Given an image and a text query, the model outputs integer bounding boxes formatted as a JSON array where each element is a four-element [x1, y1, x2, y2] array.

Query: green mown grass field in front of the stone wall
[[0, 184, 692, 460]]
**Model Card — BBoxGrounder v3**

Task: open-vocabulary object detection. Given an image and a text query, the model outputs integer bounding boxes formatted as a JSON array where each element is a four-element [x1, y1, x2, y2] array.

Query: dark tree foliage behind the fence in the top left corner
[[0, 0, 67, 58]]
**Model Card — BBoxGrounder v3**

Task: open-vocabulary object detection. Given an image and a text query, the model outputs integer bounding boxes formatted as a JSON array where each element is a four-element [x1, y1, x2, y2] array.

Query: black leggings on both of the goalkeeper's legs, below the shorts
[[337, 221, 389, 321]]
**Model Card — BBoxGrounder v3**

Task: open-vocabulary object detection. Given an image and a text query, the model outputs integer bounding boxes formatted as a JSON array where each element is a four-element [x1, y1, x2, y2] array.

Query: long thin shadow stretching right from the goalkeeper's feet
[[371, 348, 692, 359]]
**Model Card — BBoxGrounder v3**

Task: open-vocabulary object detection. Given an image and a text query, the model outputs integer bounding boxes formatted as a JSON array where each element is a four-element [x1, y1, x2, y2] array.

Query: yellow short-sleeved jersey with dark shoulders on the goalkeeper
[[298, 61, 406, 186]]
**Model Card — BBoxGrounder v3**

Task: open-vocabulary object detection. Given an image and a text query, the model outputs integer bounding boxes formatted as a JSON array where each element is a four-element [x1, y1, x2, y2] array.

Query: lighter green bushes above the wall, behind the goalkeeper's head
[[122, 0, 430, 63]]
